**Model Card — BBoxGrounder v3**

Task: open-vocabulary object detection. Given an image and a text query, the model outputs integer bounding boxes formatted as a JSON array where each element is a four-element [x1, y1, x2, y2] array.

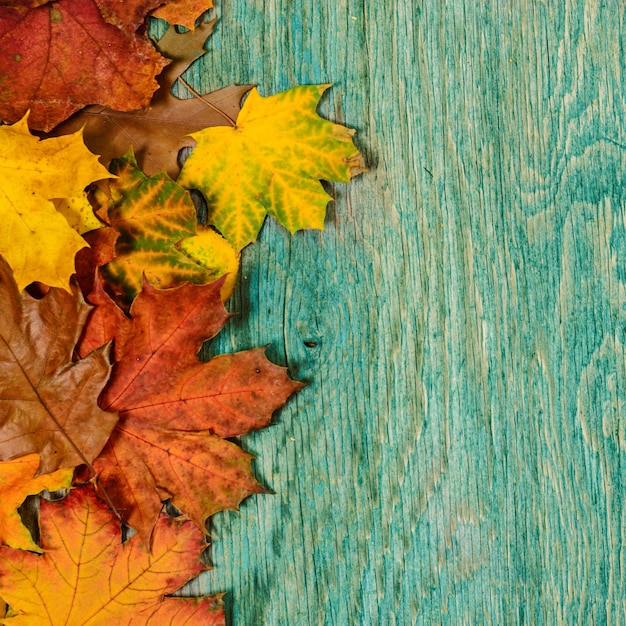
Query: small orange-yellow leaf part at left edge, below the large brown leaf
[[0, 454, 74, 552]]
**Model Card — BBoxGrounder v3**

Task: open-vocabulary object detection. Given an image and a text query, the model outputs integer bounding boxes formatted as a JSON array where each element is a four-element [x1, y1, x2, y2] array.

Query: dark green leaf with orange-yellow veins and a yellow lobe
[[96, 153, 239, 302]]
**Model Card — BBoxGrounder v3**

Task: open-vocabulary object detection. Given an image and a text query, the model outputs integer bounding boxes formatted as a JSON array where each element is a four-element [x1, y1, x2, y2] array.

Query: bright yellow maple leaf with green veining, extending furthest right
[[178, 85, 364, 249]]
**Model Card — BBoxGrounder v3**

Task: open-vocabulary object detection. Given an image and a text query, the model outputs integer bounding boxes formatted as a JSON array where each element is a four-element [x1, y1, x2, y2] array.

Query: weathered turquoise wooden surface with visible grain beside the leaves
[[176, 0, 626, 626]]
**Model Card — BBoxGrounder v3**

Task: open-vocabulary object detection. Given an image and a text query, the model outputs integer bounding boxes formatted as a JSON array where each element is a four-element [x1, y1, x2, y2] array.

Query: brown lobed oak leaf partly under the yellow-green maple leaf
[[52, 22, 250, 178]]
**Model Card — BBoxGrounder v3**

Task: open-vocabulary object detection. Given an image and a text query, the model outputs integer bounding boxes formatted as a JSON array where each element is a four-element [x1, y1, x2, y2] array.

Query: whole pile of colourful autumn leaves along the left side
[[0, 0, 363, 625]]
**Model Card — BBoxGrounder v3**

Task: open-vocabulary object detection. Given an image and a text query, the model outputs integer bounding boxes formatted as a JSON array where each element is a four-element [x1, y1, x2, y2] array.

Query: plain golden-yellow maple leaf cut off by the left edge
[[0, 118, 111, 290]]
